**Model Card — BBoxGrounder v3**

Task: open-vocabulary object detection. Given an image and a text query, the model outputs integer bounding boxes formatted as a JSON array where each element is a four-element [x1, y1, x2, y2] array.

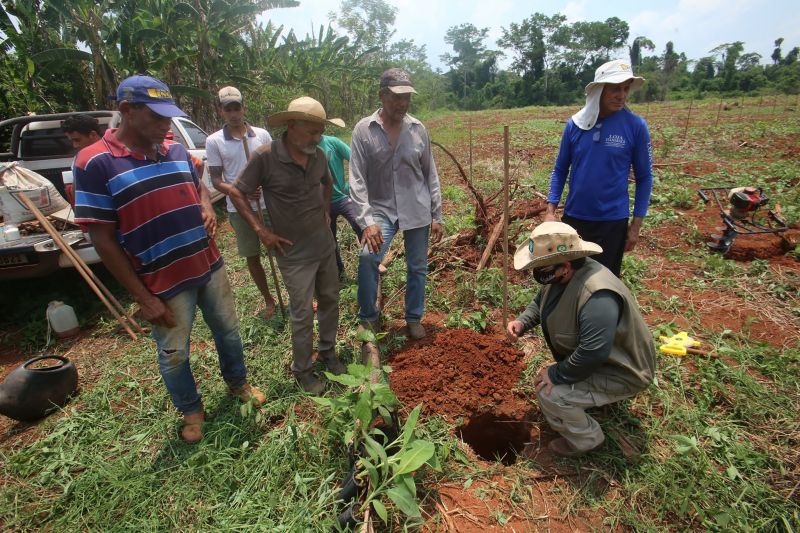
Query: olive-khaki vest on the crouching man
[[539, 258, 656, 389]]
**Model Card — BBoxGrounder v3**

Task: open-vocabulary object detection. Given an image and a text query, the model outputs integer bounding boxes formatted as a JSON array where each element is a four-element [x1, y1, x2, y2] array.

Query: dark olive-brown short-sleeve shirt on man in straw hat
[[234, 135, 335, 264]]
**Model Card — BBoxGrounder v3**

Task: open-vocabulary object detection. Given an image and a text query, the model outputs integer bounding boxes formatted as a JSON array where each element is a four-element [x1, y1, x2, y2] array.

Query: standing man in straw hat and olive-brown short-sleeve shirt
[[230, 96, 346, 394]]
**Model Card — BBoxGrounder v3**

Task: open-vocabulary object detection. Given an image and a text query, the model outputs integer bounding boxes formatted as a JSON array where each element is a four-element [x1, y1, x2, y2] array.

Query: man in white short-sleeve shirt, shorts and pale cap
[[206, 87, 275, 320]]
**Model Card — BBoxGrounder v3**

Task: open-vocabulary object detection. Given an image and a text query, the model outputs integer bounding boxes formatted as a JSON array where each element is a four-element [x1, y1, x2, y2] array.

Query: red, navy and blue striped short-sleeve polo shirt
[[74, 129, 223, 299]]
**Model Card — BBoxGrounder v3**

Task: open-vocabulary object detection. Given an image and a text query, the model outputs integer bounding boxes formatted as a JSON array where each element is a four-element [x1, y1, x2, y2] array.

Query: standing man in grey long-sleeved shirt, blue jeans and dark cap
[[350, 68, 442, 339]]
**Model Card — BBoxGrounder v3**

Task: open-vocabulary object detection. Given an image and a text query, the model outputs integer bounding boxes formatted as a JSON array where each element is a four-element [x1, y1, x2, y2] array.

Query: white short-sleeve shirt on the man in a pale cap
[[206, 124, 272, 213]]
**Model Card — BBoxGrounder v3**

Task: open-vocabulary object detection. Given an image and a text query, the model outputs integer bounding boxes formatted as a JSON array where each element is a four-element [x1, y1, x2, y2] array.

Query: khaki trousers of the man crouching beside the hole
[[536, 372, 642, 451]]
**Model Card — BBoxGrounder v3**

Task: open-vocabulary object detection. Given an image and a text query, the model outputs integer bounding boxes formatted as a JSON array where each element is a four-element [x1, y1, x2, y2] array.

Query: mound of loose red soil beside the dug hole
[[389, 329, 528, 420]]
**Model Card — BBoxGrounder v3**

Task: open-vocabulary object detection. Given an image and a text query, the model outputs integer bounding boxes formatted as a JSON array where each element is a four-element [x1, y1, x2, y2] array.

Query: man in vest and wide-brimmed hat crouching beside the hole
[[507, 222, 655, 457]]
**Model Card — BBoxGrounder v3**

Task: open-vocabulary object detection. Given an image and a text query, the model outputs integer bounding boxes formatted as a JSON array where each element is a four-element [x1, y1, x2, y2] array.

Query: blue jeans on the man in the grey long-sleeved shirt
[[358, 213, 431, 322]]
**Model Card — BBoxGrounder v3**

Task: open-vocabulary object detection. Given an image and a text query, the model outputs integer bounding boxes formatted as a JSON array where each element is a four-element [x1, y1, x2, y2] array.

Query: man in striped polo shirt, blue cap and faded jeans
[[74, 76, 265, 443]]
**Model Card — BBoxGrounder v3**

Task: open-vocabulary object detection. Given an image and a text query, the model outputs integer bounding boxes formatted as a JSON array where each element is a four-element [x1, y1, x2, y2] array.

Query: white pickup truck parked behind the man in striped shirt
[[0, 111, 224, 281]]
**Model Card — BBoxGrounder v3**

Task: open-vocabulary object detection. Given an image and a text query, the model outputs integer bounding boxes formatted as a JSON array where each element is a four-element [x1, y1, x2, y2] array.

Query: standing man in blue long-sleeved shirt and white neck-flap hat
[[544, 60, 653, 276]]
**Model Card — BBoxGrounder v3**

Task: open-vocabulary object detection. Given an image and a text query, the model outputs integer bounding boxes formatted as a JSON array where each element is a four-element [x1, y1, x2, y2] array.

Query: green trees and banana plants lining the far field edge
[[0, 0, 800, 127]]
